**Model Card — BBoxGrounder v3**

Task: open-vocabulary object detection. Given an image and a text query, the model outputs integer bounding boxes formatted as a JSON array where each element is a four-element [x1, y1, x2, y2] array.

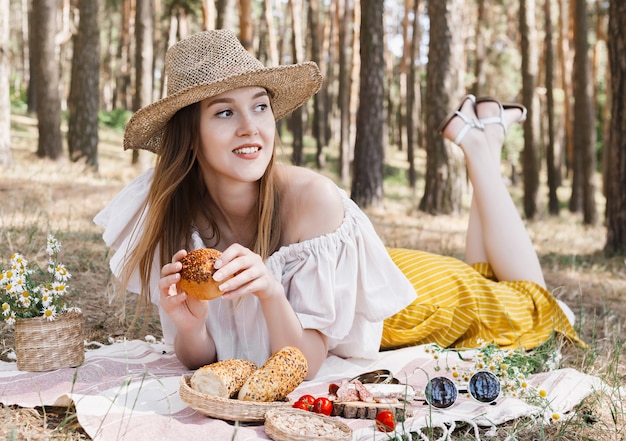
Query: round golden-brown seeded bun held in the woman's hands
[[180, 248, 222, 300]]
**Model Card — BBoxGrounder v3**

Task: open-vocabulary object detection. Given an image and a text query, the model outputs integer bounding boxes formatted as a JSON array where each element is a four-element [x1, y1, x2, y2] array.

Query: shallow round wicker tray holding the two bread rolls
[[179, 375, 292, 422]]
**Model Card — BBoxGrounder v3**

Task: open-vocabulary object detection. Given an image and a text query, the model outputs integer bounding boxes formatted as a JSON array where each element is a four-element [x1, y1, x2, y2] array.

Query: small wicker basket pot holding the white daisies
[[15, 312, 85, 372]]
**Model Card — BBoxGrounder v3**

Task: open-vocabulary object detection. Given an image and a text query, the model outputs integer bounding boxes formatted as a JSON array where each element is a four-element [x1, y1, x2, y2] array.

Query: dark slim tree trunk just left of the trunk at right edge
[[573, 0, 598, 224]]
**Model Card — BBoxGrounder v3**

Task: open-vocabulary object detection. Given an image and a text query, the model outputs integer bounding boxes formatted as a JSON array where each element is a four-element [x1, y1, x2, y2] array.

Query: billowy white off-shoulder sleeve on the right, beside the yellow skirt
[[267, 191, 416, 358]]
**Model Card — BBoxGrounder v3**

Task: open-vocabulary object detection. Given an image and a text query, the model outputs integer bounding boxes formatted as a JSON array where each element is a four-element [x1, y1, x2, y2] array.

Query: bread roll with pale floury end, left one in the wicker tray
[[190, 358, 258, 398]]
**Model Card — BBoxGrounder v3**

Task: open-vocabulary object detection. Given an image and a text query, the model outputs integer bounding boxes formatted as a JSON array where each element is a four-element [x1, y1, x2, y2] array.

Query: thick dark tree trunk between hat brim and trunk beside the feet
[[351, 0, 385, 208]]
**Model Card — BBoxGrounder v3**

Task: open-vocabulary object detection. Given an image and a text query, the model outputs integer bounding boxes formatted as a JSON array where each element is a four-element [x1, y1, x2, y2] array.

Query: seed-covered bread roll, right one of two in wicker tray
[[237, 346, 308, 401]]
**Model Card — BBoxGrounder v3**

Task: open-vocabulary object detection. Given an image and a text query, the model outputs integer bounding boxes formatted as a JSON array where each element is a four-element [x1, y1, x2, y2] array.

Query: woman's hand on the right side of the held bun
[[213, 244, 284, 300]]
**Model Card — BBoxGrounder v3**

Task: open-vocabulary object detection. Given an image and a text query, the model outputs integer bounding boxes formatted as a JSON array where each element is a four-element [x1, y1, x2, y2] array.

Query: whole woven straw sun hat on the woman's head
[[124, 30, 322, 153]]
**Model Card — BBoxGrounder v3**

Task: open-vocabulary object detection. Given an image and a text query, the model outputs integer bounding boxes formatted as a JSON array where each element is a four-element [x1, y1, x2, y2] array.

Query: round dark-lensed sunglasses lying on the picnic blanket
[[424, 371, 500, 409]]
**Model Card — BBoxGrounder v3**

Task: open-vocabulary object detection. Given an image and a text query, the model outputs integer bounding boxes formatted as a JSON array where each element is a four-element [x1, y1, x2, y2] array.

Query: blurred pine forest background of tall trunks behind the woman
[[0, 0, 626, 255]]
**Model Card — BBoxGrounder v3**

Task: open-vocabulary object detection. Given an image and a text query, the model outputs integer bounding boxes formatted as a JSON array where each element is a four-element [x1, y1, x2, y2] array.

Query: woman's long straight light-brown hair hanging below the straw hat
[[121, 103, 282, 302]]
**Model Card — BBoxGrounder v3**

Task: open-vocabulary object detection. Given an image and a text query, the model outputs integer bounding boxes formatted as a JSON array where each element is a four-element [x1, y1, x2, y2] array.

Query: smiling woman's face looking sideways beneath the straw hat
[[198, 87, 276, 182]]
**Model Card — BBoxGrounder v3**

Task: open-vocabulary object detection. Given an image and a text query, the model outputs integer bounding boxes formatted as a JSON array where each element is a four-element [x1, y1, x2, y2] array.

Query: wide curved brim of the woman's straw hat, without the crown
[[124, 61, 322, 153]]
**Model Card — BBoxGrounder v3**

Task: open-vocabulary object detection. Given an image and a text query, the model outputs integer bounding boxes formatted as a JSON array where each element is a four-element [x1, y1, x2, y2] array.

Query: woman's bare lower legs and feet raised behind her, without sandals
[[436, 97, 545, 286]]
